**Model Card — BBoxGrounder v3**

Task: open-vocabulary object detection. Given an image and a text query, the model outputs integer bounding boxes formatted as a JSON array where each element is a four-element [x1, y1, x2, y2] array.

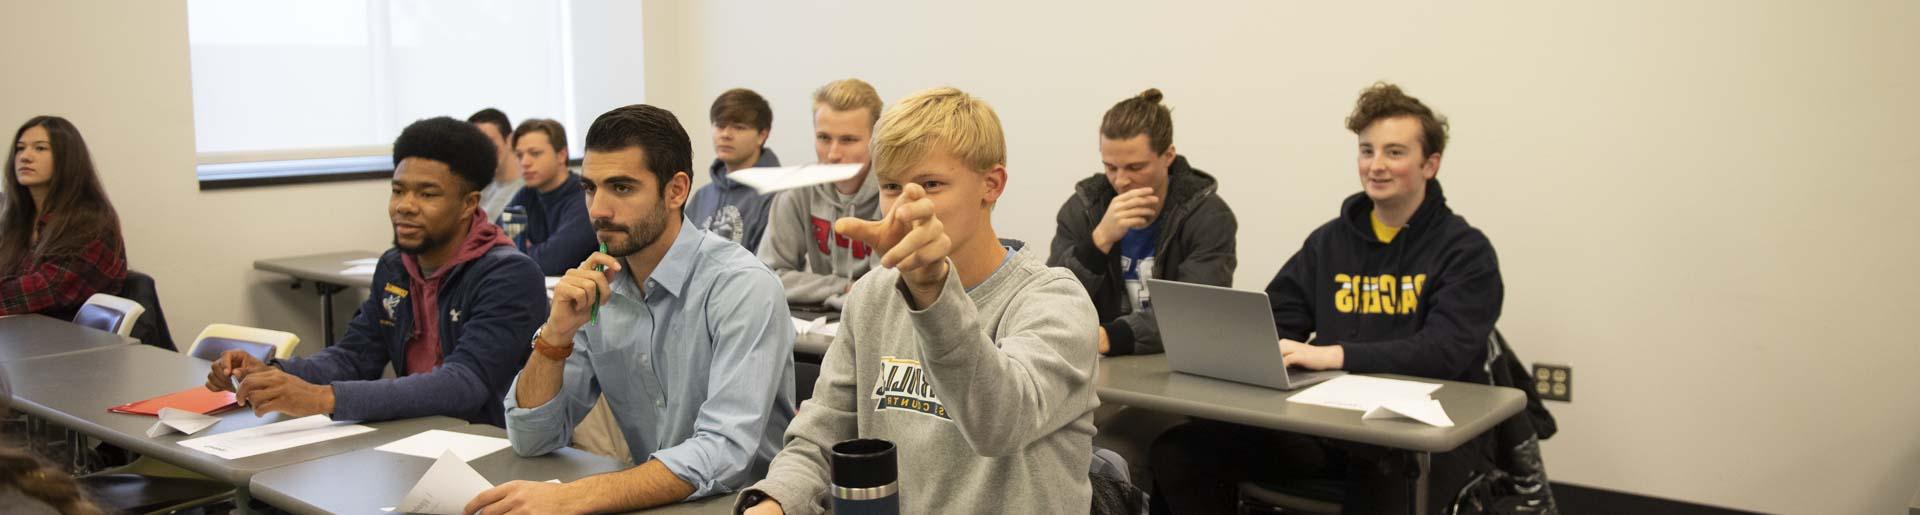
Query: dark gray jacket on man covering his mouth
[[1046, 156, 1240, 356]]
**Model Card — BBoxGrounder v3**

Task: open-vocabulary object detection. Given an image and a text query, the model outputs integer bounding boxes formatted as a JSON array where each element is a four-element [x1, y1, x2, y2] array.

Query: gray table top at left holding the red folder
[[0, 346, 467, 488]]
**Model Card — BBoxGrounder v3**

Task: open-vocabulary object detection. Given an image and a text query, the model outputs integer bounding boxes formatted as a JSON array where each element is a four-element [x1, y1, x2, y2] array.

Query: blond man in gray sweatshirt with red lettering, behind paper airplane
[[760, 79, 881, 307]]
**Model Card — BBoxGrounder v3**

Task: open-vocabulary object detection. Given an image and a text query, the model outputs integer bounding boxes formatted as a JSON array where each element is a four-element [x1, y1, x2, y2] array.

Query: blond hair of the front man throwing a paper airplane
[[874, 86, 1006, 177]]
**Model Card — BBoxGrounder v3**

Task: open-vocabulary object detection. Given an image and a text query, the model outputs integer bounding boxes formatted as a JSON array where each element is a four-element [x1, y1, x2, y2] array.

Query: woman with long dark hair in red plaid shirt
[[0, 115, 127, 321]]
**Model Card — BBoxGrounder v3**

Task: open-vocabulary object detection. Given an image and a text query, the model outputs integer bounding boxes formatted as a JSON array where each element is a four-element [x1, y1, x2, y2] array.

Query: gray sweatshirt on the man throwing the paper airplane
[[739, 242, 1100, 515]]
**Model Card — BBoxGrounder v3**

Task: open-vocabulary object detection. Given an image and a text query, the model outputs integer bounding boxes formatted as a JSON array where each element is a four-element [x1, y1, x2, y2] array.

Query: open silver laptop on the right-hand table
[[1146, 279, 1344, 390]]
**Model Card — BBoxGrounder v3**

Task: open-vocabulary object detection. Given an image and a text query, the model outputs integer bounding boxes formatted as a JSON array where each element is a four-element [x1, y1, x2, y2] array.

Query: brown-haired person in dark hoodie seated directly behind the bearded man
[[507, 119, 599, 275]]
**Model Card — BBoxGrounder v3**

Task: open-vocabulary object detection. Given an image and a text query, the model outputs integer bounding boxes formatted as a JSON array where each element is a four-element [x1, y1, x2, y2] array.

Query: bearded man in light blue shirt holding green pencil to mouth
[[467, 106, 795, 513]]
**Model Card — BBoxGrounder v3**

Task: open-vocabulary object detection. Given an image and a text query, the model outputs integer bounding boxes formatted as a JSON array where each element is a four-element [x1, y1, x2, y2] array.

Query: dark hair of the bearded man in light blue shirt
[[588, 104, 693, 192]]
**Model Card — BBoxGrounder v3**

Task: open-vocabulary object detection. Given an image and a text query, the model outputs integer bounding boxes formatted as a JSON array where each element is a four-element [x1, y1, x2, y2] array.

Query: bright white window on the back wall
[[186, 0, 610, 188]]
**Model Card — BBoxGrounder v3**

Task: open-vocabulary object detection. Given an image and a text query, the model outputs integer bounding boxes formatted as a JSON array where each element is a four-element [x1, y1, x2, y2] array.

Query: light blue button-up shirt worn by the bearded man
[[505, 221, 795, 500]]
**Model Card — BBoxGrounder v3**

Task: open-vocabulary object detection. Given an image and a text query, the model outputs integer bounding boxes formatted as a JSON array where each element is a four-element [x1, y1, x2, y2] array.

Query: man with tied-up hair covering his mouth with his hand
[[1046, 88, 1240, 356]]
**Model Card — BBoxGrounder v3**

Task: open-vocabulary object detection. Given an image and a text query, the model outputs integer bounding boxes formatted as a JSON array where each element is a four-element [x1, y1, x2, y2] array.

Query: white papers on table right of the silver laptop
[[1286, 375, 1453, 427]]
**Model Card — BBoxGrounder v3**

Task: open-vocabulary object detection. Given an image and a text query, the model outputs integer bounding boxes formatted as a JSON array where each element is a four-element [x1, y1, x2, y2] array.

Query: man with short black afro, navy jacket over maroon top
[[207, 117, 547, 425]]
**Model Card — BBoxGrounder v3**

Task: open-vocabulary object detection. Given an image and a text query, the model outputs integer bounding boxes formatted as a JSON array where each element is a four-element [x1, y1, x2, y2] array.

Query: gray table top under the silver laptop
[[1094, 354, 1526, 452]]
